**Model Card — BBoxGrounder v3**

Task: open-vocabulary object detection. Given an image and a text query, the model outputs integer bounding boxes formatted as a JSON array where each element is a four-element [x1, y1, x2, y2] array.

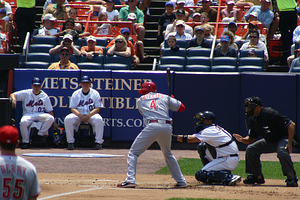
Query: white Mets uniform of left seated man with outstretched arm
[[14, 89, 54, 143]]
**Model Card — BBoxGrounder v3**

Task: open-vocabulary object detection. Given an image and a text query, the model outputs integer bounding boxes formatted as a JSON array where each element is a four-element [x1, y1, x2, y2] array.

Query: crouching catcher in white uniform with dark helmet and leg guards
[[173, 111, 241, 185]]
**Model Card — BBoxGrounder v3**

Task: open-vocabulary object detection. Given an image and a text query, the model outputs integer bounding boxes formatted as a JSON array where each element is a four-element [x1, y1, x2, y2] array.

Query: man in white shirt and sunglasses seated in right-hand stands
[[240, 30, 269, 61]]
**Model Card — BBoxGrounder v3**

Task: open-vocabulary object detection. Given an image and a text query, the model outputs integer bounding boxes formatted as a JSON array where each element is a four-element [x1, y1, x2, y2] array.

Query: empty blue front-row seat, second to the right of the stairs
[[185, 56, 211, 72]]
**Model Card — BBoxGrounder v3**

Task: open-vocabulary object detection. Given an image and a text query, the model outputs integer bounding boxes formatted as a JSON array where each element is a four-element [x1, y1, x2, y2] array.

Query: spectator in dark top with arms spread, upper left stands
[[54, 18, 90, 39]]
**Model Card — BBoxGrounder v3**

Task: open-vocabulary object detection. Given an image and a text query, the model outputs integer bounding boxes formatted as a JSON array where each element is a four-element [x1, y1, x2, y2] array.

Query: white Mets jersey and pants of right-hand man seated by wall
[[64, 88, 104, 144]]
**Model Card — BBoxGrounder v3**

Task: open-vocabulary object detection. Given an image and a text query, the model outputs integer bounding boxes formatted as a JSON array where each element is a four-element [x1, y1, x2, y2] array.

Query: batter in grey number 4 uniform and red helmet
[[117, 82, 186, 188]]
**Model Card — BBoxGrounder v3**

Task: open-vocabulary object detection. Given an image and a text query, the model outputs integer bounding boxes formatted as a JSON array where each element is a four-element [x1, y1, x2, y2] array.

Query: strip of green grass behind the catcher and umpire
[[155, 158, 300, 180]]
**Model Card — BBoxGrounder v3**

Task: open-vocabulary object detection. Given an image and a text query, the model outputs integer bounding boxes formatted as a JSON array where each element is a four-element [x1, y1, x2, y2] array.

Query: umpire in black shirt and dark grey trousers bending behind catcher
[[233, 97, 298, 187]]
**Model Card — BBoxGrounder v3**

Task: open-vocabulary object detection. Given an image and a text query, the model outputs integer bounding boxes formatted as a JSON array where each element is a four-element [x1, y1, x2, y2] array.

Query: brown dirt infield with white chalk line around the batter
[[17, 149, 300, 200]]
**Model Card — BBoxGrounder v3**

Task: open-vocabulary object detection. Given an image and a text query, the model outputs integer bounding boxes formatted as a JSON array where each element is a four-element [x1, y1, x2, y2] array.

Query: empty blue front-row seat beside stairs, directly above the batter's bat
[[158, 56, 186, 71]]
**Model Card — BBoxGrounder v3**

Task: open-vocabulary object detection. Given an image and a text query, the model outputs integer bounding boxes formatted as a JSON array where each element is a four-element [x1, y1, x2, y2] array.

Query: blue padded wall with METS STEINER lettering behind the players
[[14, 69, 300, 148]]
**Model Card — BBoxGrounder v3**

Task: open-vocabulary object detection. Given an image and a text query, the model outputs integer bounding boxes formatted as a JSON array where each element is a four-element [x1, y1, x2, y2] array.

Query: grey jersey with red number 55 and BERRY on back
[[0, 155, 41, 200]]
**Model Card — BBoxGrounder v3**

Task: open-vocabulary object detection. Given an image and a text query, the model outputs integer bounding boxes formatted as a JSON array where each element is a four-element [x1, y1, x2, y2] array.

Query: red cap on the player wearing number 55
[[0, 125, 19, 144]]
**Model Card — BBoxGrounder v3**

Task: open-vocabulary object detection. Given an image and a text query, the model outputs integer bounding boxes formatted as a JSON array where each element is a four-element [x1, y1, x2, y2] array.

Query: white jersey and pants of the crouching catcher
[[193, 124, 239, 171]]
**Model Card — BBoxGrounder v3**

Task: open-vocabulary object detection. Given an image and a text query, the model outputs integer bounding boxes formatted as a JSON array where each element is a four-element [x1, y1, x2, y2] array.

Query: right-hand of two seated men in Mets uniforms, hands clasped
[[64, 76, 104, 150]]
